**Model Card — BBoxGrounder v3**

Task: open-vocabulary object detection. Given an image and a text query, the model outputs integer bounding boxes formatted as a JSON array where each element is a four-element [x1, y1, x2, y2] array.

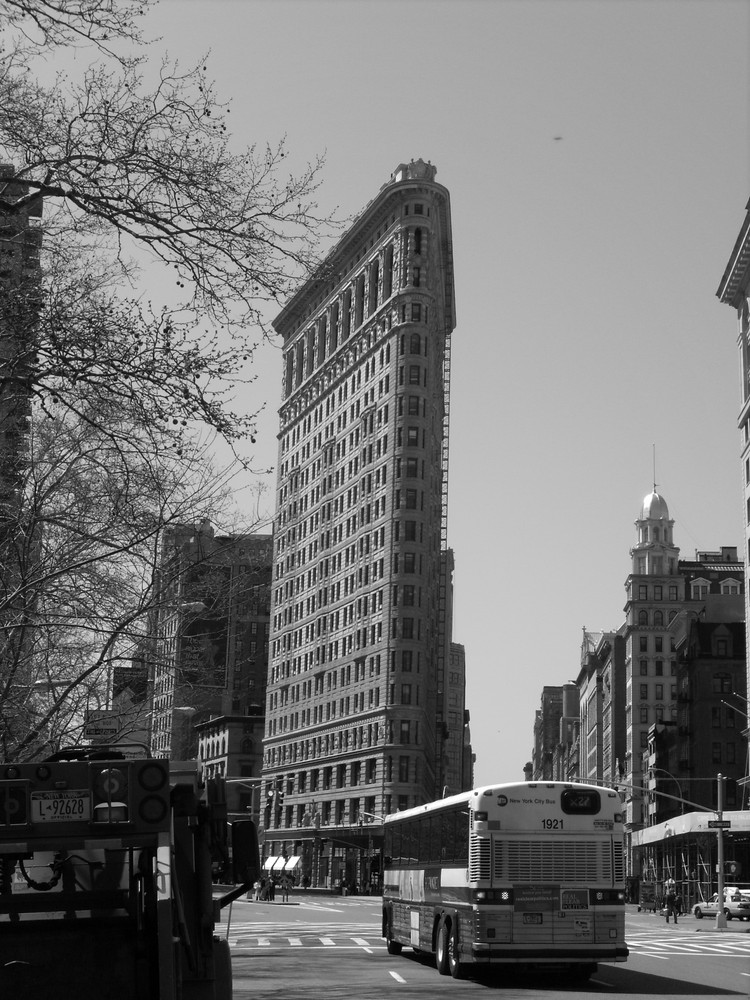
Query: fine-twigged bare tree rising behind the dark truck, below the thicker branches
[[0, 398, 262, 760]]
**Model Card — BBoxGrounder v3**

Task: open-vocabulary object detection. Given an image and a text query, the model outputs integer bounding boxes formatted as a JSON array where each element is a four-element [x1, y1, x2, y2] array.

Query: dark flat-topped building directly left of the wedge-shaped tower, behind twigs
[[149, 522, 272, 817]]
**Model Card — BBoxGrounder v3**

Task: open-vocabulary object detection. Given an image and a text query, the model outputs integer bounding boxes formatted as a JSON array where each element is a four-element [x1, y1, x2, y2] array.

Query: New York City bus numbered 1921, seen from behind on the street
[[382, 782, 628, 981]]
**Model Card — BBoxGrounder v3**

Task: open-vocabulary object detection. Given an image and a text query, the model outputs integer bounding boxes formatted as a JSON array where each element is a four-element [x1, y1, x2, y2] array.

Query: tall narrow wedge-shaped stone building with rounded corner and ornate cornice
[[264, 160, 463, 884]]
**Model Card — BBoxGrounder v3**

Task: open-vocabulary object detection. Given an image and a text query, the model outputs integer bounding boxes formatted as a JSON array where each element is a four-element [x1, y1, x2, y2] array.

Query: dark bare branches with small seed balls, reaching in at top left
[[0, 0, 331, 448]]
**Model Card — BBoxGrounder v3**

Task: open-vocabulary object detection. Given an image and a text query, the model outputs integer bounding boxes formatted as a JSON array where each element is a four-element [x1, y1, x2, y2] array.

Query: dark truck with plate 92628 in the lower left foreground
[[0, 747, 260, 1000]]
